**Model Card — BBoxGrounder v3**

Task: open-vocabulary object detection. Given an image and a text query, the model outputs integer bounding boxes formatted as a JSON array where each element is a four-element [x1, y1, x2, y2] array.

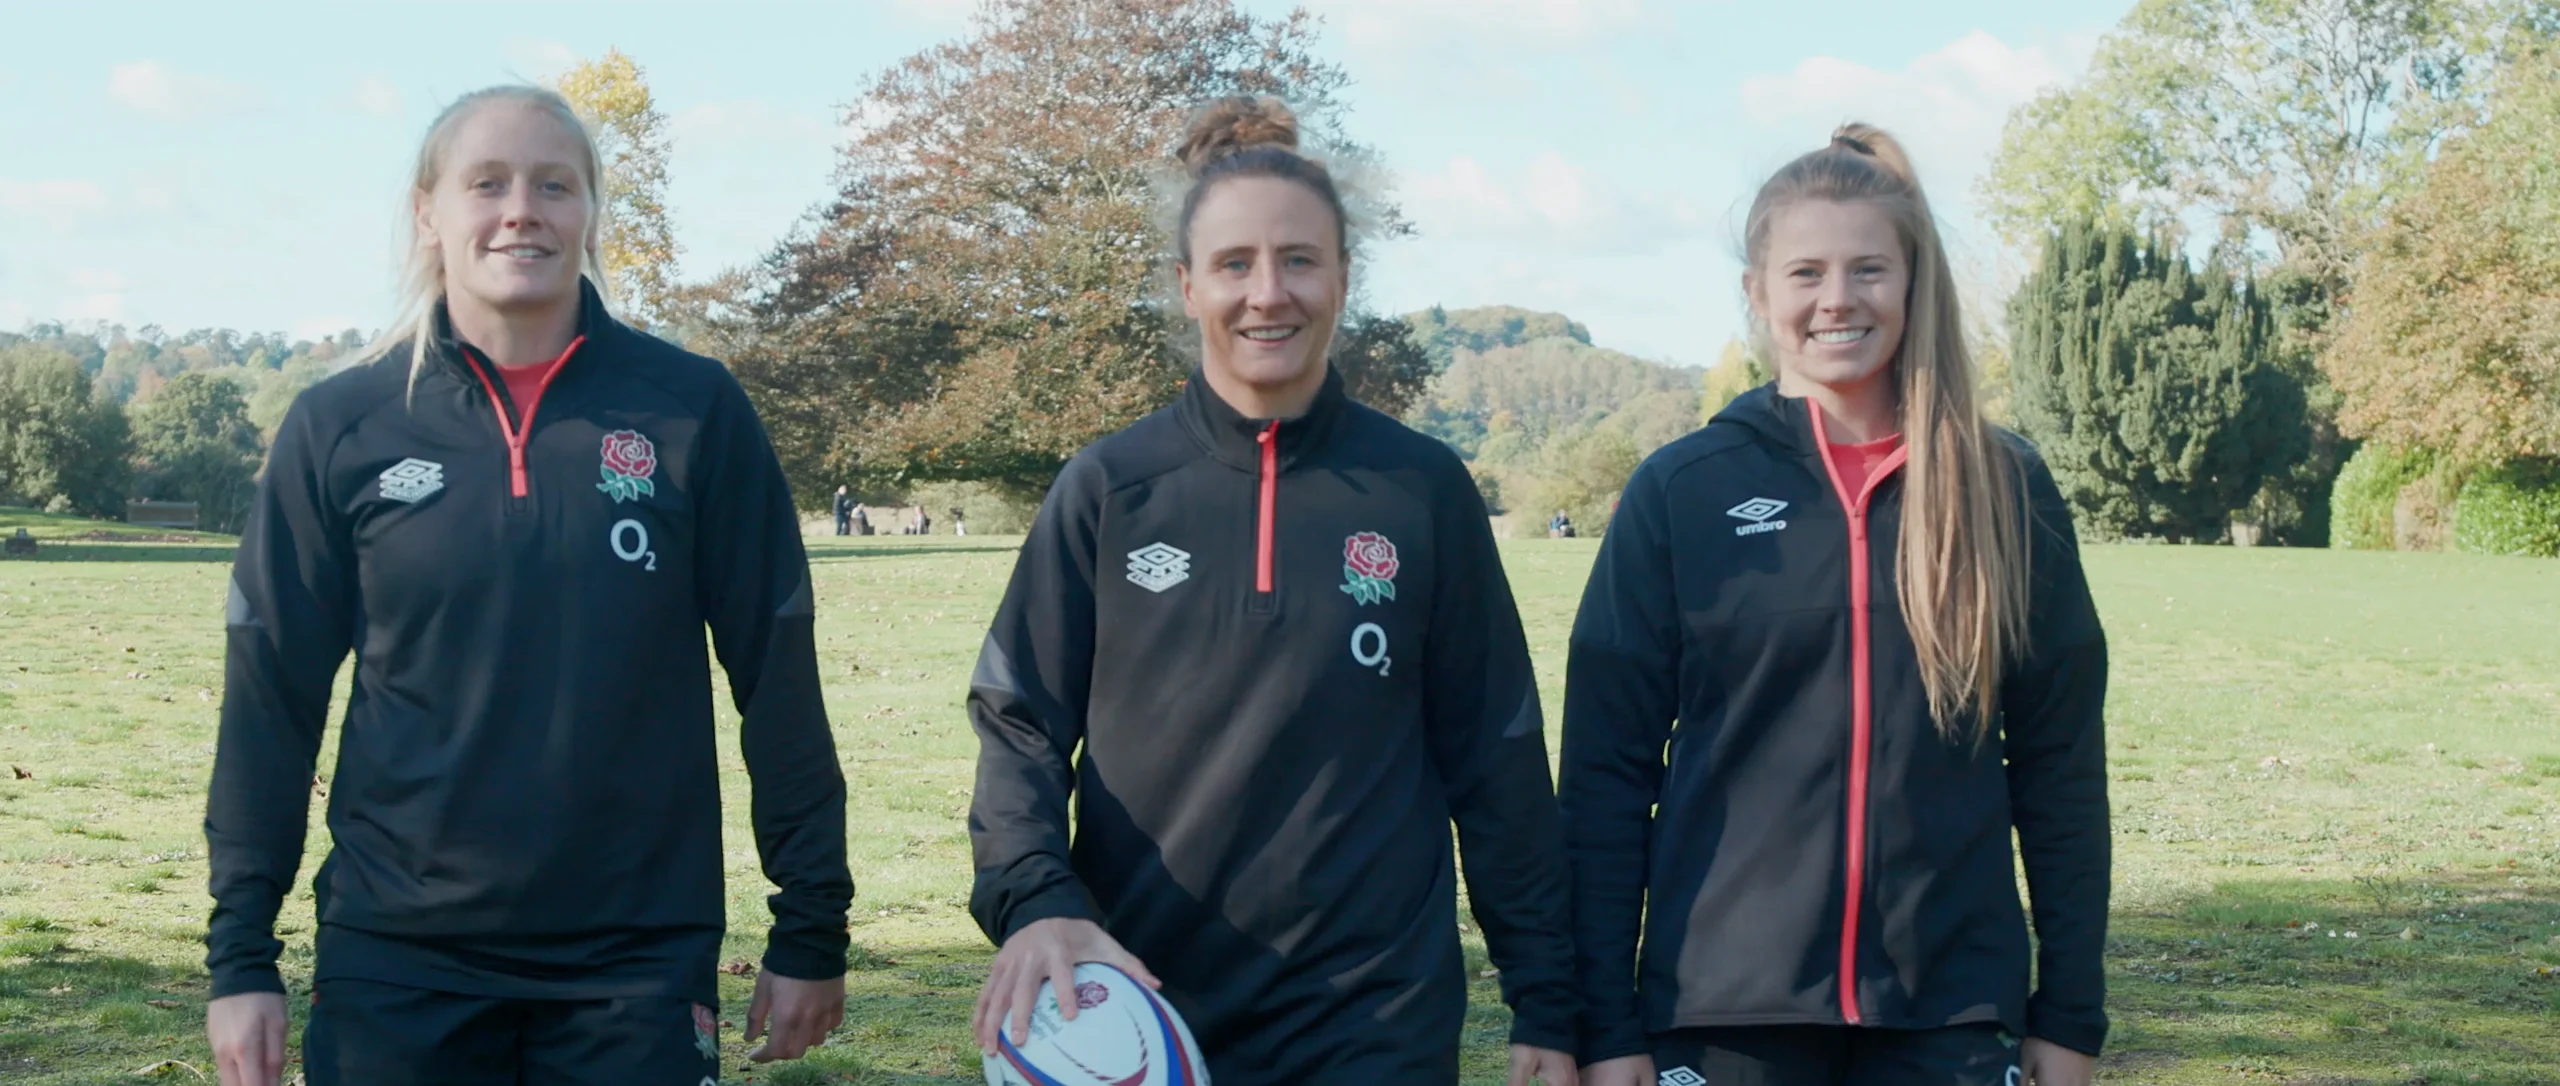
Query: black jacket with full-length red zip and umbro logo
[[1559, 387, 2109, 1060]]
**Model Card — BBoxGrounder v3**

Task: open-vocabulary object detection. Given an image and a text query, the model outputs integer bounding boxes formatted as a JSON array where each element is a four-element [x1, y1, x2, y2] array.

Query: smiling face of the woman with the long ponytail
[[1743, 200, 1912, 394]]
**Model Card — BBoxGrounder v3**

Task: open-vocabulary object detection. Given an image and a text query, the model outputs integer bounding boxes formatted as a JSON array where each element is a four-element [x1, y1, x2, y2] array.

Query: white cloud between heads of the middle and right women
[[1405, 151, 1708, 254]]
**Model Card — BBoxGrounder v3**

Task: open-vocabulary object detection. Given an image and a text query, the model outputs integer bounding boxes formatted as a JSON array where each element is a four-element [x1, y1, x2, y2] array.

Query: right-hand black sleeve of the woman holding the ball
[[1423, 461, 1582, 1053]]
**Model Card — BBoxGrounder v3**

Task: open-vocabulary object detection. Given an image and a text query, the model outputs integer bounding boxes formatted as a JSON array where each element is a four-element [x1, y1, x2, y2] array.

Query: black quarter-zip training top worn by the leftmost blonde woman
[[205, 289, 852, 1004]]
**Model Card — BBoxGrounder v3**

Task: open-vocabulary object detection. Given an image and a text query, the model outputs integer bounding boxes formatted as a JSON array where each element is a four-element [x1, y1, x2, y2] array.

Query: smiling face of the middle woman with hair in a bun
[[1180, 177, 1352, 417]]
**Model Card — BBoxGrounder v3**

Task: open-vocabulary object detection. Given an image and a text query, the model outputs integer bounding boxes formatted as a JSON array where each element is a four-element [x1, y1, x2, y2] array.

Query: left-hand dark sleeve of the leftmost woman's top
[[205, 397, 356, 999]]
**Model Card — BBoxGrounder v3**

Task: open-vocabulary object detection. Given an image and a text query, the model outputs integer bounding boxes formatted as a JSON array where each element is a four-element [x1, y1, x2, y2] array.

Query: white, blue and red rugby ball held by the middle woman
[[986, 960, 1208, 1086]]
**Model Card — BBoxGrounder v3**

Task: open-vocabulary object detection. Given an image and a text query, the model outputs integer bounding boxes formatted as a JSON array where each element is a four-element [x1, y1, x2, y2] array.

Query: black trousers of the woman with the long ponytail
[[1654, 1025, 2020, 1086]]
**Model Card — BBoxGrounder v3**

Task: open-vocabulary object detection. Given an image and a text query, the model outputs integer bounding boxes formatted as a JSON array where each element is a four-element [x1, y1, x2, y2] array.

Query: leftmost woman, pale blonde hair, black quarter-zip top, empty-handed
[[205, 87, 852, 1086]]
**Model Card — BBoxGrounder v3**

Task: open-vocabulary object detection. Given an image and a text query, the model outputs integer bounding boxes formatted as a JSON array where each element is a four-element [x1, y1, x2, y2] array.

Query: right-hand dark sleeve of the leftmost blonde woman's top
[[694, 382, 852, 981]]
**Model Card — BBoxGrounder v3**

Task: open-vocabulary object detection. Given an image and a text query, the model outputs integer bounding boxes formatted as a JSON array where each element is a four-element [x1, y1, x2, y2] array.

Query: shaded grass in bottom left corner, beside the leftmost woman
[[0, 925, 232, 1086]]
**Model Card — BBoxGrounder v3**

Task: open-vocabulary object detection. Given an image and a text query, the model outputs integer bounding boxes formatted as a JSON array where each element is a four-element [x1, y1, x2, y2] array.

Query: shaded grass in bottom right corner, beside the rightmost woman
[[2102, 868, 2560, 1086]]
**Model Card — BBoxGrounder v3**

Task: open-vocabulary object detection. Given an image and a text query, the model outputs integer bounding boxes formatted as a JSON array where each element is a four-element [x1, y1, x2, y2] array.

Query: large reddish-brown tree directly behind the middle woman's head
[[732, 0, 1405, 489]]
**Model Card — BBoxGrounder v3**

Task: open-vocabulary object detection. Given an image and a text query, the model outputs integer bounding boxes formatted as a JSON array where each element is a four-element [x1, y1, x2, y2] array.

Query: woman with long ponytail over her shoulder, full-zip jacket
[[1559, 126, 2109, 1086]]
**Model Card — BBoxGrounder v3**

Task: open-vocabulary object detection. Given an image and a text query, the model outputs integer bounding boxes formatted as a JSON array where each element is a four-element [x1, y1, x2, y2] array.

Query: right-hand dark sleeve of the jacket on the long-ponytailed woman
[[1999, 445, 2112, 1055]]
